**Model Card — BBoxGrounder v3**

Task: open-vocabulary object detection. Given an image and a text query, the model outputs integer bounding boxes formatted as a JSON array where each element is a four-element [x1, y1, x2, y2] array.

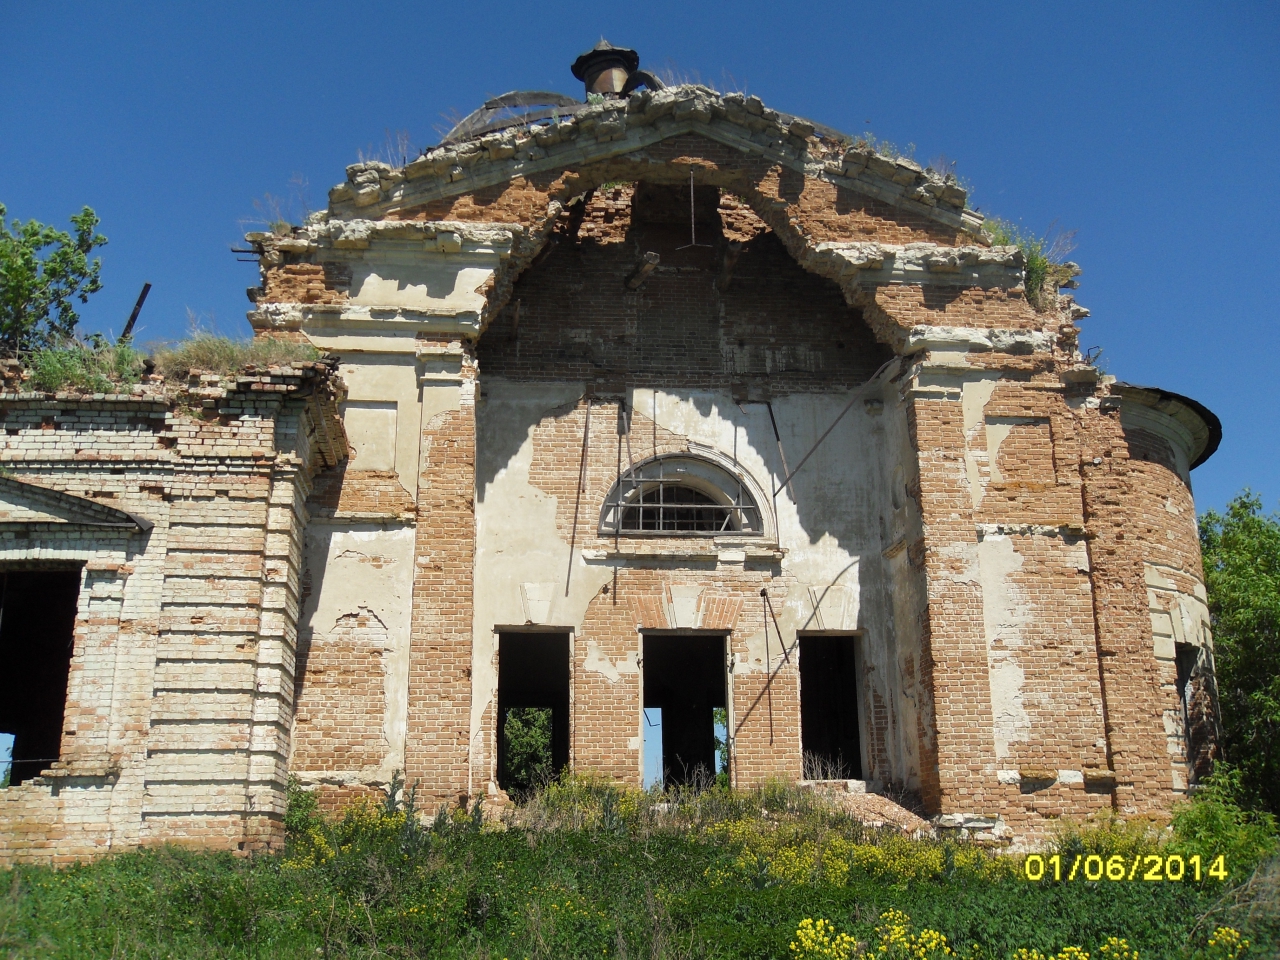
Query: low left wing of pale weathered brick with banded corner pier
[[0, 367, 346, 863]]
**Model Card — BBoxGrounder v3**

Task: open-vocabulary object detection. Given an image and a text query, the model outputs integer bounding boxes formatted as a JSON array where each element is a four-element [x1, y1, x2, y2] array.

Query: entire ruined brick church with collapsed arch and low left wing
[[0, 46, 1220, 860]]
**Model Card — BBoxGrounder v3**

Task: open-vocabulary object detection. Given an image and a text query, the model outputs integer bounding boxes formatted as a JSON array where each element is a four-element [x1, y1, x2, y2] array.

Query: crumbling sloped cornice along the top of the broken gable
[[328, 84, 982, 232]]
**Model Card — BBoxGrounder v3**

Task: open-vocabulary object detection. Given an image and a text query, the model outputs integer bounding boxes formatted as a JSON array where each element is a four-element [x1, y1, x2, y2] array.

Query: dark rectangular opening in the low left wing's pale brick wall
[[0, 570, 81, 785]]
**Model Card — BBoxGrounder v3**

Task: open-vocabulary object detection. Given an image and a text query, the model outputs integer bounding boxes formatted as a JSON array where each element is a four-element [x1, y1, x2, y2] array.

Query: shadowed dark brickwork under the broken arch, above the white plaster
[[480, 181, 888, 392]]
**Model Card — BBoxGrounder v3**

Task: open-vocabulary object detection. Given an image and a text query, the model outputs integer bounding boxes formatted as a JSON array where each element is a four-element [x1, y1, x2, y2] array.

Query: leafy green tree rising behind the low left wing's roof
[[0, 204, 106, 355]]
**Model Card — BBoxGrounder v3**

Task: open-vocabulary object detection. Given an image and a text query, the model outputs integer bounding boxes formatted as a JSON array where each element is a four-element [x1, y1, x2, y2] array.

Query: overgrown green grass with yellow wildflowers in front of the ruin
[[0, 780, 1274, 960]]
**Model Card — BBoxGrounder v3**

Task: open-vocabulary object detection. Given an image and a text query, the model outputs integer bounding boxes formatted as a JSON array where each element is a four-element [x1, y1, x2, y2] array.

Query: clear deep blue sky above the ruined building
[[0, 0, 1280, 509]]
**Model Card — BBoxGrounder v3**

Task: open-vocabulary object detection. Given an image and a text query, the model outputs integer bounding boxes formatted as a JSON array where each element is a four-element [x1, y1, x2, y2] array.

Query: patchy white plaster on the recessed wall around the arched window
[[471, 379, 918, 781]]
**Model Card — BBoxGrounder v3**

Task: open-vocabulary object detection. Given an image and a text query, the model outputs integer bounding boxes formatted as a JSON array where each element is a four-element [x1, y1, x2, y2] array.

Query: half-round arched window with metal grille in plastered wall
[[600, 454, 764, 536]]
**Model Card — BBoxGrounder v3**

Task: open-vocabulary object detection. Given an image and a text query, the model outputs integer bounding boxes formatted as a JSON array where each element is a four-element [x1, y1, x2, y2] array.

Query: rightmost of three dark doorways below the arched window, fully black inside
[[800, 635, 863, 780]]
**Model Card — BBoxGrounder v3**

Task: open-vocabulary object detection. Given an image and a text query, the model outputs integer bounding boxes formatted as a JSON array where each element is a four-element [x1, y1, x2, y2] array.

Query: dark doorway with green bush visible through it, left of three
[[498, 634, 570, 797]]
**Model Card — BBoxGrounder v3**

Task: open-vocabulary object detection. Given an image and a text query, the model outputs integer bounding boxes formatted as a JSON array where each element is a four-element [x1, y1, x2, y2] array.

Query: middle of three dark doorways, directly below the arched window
[[644, 635, 726, 787]]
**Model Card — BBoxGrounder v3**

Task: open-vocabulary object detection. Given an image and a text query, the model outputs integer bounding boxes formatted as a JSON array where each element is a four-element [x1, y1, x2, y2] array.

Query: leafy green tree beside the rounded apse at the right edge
[[1201, 489, 1280, 813]]
